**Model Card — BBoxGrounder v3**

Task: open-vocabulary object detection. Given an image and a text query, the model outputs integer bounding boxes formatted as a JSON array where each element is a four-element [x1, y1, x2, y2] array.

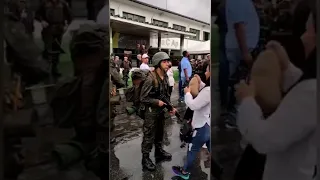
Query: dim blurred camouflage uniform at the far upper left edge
[[4, 4, 48, 85]]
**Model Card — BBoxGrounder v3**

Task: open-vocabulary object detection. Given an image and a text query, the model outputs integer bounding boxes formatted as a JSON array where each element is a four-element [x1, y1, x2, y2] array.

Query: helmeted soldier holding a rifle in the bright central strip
[[140, 52, 176, 171]]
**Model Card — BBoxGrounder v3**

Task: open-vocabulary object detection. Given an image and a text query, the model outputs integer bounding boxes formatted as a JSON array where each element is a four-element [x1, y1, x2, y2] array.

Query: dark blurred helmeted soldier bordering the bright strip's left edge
[[70, 24, 109, 180]]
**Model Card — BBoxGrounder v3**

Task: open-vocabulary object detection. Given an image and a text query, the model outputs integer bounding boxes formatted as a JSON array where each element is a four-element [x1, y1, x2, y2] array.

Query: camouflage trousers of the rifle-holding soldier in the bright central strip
[[141, 109, 166, 154]]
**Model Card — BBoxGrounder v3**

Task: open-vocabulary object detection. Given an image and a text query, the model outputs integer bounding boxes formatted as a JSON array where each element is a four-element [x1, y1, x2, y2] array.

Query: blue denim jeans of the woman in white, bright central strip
[[183, 124, 211, 171]]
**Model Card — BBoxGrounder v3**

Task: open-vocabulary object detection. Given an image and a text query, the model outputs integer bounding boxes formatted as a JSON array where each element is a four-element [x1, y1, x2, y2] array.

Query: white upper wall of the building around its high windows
[[110, 0, 210, 40]]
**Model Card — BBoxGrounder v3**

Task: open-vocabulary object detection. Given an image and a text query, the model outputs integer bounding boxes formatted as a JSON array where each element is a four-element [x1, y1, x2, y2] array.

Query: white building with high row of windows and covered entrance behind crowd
[[110, 0, 210, 56]]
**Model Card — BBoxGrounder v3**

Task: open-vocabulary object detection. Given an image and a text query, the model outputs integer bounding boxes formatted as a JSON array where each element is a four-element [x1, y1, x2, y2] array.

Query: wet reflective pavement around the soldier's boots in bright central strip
[[111, 87, 210, 180]]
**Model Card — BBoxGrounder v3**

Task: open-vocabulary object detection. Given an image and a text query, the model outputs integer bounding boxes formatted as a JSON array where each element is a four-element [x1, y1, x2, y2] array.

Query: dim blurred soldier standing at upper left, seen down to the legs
[[36, 0, 72, 77]]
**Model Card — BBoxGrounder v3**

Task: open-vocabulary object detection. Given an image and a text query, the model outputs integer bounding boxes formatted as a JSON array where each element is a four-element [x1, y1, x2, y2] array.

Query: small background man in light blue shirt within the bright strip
[[180, 51, 192, 101]]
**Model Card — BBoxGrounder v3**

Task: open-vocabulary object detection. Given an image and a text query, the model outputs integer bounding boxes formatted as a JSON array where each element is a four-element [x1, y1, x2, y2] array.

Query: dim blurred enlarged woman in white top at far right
[[236, 2, 317, 180]]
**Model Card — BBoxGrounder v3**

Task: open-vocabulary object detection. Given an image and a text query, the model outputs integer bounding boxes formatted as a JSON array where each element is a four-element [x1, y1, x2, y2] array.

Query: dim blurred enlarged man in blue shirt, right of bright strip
[[225, 0, 260, 126]]
